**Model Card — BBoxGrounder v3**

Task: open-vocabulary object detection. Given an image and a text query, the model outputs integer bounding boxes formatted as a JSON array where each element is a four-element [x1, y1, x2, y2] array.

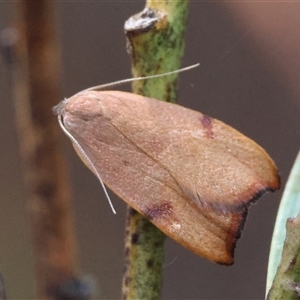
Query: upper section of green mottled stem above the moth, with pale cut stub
[[125, 1, 188, 102]]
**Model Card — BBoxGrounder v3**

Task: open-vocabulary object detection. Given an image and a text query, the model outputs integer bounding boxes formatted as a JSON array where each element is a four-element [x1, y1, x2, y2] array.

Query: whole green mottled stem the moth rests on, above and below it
[[122, 1, 188, 300]]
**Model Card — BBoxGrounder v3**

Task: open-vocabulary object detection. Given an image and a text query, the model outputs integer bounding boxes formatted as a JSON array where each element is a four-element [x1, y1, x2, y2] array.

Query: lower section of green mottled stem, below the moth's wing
[[123, 207, 166, 299]]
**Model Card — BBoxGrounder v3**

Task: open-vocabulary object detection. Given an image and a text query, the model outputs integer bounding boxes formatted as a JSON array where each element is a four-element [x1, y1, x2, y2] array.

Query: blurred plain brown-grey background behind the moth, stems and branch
[[0, 1, 300, 299]]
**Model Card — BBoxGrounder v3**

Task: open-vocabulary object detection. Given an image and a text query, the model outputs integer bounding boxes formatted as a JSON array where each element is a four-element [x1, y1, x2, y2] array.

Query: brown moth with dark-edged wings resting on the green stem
[[54, 68, 280, 265]]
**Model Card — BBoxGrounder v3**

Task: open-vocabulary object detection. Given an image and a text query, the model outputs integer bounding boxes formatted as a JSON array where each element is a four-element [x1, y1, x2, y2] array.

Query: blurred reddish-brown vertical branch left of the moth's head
[[14, 0, 76, 299]]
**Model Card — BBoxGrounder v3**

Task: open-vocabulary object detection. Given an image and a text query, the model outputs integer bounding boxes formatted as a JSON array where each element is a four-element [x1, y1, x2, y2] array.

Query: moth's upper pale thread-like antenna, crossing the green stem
[[80, 63, 200, 93]]
